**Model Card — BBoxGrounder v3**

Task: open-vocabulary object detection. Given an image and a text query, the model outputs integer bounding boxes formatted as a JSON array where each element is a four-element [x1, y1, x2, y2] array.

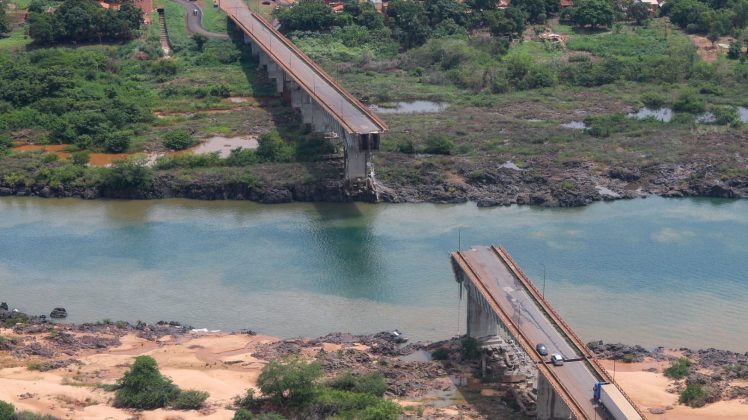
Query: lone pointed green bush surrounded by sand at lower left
[[114, 356, 179, 410]]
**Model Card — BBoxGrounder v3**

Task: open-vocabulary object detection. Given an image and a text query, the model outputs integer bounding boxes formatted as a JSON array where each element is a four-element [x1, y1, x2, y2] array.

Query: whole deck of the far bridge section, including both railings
[[219, 0, 387, 134]]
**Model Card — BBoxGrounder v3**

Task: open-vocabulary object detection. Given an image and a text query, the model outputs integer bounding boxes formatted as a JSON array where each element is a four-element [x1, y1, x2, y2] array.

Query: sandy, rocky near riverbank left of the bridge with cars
[[0, 306, 524, 419]]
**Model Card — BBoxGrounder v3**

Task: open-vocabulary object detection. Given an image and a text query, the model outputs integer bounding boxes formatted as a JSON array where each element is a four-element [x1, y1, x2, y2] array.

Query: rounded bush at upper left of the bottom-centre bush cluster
[[257, 359, 322, 406]]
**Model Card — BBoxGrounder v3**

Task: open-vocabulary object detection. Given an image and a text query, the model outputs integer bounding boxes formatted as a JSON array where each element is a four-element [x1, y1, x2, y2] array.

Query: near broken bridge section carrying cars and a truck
[[452, 246, 644, 420]]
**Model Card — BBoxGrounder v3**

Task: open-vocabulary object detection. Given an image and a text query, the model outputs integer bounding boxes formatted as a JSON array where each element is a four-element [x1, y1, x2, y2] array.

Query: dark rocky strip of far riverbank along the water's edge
[[0, 153, 748, 207]]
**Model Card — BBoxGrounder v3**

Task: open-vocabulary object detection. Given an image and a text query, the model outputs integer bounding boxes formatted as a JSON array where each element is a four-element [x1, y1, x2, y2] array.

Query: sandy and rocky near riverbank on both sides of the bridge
[[0, 304, 748, 419]]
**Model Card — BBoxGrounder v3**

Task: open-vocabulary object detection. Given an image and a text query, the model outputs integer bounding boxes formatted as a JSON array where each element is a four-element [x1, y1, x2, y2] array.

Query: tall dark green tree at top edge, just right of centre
[[387, 0, 431, 48]]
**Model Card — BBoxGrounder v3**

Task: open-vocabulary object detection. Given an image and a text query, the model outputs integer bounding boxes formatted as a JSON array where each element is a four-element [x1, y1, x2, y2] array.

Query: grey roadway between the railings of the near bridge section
[[461, 247, 604, 418]]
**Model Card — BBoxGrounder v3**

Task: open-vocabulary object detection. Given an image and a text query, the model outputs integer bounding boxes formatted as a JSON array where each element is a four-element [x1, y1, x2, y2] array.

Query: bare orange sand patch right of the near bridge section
[[602, 359, 748, 420]]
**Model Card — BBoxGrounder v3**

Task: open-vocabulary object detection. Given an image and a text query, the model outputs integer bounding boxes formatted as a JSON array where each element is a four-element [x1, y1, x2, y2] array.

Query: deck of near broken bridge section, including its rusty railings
[[453, 247, 644, 419]]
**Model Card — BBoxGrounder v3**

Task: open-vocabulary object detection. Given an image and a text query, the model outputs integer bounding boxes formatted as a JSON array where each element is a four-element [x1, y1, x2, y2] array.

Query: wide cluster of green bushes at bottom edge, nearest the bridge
[[243, 359, 401, 420]]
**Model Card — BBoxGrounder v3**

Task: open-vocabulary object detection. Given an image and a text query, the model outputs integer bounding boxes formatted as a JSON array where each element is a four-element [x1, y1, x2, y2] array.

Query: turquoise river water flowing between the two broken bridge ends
[[0, 197, 748, 351]]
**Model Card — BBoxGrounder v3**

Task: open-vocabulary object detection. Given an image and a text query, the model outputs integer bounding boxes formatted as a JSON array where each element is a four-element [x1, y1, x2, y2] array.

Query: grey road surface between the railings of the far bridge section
[[219, 0, 383, 134]]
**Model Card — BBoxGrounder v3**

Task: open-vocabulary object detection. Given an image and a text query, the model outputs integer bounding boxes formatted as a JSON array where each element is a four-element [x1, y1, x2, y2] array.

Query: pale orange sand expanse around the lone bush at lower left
[[0, 330, 275, 419]]
